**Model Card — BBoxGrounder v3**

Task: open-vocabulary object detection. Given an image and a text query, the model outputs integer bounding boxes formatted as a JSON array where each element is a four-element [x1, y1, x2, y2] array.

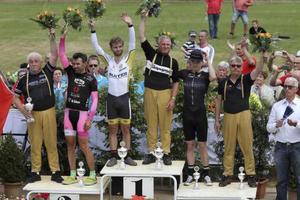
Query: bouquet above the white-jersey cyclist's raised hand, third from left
[[84, 0, 105, 19]]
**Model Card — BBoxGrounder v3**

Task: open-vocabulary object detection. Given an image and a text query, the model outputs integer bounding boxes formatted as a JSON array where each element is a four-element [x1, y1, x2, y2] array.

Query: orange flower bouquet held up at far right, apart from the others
[[250, 33, 272, 52]]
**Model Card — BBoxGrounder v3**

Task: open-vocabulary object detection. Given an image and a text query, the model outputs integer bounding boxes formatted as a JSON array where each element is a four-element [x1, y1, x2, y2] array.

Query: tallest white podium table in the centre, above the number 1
[[100, 160, 184, 200]]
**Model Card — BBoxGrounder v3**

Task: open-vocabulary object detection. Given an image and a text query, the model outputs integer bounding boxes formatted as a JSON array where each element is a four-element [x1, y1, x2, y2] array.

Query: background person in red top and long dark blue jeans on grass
[[205, 0, 223, 39]]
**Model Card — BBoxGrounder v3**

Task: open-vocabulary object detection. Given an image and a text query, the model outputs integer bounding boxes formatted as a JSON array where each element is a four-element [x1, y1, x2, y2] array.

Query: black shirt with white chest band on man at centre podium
[[141, 40, 178, 90]]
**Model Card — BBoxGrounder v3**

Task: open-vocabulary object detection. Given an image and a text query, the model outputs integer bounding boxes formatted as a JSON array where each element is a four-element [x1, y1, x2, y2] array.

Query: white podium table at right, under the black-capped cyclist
[[177, 183, 256, 200]]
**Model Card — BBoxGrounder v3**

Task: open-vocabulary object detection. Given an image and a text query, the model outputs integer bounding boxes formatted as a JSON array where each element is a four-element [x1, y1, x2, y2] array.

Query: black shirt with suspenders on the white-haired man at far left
[[14, 62, 55, 111]]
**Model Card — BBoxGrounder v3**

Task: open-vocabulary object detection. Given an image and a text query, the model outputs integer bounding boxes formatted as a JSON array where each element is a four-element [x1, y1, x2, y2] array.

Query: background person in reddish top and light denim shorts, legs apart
[[229, 0, 253, 37]]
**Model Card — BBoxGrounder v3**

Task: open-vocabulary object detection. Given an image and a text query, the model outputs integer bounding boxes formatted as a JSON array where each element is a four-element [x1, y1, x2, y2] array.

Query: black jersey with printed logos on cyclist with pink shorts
[[65, 66, 97, 111]]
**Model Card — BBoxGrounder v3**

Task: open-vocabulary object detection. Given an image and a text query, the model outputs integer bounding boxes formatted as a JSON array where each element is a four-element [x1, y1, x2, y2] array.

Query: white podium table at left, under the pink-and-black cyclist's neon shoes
[[23, 176, 110, 200]]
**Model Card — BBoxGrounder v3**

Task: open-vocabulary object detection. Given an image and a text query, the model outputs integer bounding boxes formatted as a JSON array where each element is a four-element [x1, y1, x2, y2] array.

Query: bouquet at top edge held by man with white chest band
[[136, 0, 161, 17]]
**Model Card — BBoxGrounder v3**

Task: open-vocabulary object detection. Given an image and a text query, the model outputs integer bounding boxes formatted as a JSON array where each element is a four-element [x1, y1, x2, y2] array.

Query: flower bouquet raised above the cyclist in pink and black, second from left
[[63, 7, 83, 31]]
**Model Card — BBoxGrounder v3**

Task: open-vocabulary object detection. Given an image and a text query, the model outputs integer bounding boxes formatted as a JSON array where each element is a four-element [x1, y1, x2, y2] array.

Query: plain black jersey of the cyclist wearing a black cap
[[178, 69, 210, 111]]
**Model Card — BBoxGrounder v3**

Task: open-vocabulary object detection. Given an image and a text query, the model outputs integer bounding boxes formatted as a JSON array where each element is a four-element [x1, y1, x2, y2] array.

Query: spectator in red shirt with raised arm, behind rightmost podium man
[[234, 40, 256, 74]]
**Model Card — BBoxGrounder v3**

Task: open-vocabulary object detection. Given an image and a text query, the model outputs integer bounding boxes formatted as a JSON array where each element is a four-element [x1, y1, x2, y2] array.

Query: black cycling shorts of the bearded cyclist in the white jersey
[[106, 93, 131, 124]]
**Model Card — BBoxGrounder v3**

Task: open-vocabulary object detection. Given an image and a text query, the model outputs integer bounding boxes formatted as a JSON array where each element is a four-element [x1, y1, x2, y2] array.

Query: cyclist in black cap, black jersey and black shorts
[[178, 49, 216, 185]]
